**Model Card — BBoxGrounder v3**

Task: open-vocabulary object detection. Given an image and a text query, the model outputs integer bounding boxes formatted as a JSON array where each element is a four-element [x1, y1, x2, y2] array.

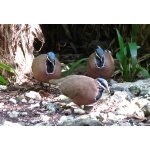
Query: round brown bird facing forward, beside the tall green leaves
[[87, 46, 115, 79]]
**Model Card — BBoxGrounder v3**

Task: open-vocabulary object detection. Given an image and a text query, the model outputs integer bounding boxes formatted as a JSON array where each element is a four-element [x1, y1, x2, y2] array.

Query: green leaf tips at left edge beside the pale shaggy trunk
[[0, 62, 15, 85]]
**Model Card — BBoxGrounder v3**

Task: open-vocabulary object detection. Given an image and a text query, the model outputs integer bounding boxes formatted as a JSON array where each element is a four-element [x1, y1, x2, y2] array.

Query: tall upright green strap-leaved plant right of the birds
[[116, 25, 150, 81]]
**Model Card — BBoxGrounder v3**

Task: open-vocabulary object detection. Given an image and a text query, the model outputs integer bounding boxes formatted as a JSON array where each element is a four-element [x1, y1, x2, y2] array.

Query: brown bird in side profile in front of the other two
[[49, 75, 109, 107]]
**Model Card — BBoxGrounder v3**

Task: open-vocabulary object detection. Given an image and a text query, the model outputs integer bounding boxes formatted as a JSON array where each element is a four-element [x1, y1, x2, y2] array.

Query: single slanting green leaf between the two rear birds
[[63, 58, 88, 77]]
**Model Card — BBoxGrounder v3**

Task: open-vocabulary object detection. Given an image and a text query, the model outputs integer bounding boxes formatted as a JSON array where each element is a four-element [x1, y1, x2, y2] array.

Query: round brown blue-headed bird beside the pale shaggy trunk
[[32, 52, 61, 83]]
